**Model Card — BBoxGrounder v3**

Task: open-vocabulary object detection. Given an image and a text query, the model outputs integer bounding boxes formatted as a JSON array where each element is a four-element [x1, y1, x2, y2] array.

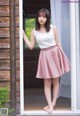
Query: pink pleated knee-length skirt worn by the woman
[[36, 45, 70, 79]]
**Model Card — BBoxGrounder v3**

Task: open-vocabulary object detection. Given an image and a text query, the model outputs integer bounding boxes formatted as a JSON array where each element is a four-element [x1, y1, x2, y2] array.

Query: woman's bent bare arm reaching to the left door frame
[[23, 30, 36, 50]]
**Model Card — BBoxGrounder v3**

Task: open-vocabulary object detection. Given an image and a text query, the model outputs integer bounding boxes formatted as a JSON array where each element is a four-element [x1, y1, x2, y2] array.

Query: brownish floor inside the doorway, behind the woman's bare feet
[[24, 88, 71, 111]]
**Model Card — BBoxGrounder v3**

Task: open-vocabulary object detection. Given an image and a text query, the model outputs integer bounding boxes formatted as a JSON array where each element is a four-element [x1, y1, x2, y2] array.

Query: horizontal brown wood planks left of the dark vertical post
[[0, 0, 10, 87]]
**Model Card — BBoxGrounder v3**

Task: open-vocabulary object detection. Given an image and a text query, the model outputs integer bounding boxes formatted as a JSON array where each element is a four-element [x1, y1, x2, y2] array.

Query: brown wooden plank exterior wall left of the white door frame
[[0, 0, 20, 114]]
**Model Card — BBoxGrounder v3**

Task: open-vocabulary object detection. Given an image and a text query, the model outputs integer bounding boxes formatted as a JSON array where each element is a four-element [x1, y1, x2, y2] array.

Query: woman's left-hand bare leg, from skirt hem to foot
[[44, 79, 51, 111]]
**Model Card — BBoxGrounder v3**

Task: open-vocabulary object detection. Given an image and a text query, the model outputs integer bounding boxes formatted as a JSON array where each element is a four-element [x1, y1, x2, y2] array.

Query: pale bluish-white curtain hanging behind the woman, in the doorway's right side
[[50, 0, 71, 98]]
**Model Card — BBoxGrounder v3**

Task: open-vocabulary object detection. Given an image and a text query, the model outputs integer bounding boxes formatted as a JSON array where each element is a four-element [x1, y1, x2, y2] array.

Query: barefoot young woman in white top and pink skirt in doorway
[[23, 8, 70, 113]]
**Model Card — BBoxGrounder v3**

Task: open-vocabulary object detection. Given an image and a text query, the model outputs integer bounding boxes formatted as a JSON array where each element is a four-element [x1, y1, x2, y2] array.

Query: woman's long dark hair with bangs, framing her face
[[36, 8, 50, 32]]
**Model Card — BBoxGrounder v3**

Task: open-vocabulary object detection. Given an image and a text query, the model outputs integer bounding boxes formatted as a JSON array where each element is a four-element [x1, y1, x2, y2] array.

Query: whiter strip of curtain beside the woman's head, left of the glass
[[50, 0, 61, 40]]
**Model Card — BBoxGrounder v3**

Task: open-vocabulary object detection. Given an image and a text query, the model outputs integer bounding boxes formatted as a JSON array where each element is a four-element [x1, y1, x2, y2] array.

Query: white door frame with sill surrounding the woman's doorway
[[19, 0, 80, 115]]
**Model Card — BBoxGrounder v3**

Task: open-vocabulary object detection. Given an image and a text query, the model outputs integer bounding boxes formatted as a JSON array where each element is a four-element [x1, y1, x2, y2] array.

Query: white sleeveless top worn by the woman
[[34, 25, 56, 49]]
